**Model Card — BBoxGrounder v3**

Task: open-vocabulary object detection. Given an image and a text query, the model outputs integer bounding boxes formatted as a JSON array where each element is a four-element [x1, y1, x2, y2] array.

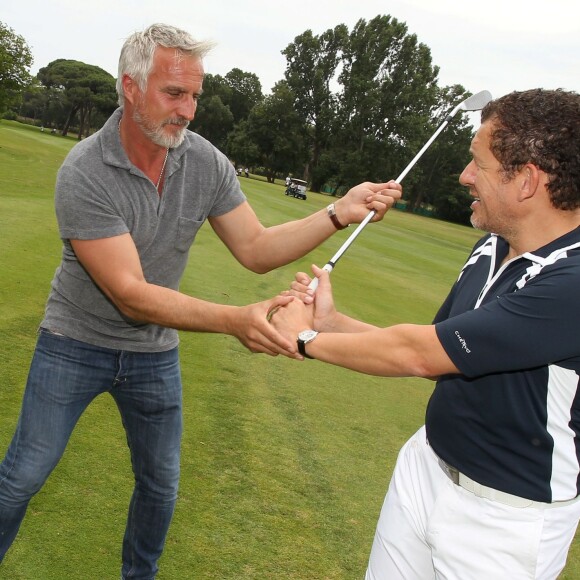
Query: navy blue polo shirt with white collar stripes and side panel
[[426, 228, 580, 502]]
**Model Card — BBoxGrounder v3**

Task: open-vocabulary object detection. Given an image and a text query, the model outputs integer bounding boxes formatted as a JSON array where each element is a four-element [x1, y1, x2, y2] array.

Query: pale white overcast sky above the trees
[[0, 0, 580, 103]]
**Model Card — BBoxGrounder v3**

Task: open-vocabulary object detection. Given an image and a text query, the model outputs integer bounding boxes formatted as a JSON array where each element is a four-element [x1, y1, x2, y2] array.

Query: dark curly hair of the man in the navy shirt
[[481, 89, 580, 210]]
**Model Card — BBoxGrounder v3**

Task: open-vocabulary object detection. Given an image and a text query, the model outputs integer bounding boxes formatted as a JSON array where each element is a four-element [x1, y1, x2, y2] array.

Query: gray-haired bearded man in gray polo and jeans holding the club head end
[[0, 25, 401, 580]]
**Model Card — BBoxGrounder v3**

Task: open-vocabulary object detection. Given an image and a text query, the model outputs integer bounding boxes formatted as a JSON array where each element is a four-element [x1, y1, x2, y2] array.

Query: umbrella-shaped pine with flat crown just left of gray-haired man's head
[[38, 59, 117, 139]]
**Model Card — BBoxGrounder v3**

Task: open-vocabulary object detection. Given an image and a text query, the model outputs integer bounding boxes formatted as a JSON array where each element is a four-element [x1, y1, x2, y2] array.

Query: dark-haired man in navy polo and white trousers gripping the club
[[272, 89, 580, 580]]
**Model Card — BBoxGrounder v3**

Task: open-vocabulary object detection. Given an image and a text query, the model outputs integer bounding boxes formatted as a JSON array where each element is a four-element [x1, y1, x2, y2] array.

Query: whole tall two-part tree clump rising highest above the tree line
[[283, 16, 439, 191]]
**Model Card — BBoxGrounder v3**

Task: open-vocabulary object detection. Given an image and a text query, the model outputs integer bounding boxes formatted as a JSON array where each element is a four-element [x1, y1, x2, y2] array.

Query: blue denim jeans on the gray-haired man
[[0, 330, 182, 579]]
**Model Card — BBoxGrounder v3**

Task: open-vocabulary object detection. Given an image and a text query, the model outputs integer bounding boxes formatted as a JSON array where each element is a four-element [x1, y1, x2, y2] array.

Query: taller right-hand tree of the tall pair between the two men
[[334, 16, 439, 186]]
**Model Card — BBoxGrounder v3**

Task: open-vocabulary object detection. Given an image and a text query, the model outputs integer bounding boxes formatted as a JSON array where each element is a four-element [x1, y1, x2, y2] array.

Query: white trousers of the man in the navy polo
[[366, 427, 580, 580]]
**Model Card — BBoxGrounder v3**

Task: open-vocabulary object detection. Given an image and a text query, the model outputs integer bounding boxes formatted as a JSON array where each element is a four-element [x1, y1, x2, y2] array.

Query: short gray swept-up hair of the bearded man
[[117, 24, 215, 106]]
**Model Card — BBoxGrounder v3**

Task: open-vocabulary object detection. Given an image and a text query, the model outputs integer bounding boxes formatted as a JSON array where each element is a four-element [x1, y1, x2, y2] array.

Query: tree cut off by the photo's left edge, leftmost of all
[[0, 22, 33, 113]]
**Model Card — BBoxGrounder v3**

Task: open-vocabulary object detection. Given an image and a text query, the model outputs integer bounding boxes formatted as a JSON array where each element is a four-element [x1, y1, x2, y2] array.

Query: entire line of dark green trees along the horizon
[[0, 15, 473, 223]]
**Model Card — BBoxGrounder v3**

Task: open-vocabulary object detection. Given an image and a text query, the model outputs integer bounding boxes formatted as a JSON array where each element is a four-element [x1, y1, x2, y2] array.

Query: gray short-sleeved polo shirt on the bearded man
[[41, 109, 245, 352]]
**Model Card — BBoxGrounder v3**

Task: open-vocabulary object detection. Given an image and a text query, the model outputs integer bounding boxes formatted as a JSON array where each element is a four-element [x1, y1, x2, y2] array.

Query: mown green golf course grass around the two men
[[0, 121, 580, 580]]
